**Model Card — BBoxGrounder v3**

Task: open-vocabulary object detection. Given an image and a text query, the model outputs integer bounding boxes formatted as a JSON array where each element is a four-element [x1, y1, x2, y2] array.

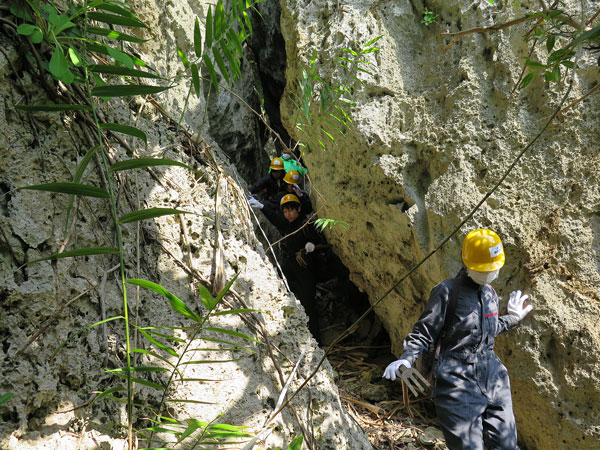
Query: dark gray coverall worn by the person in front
[[400, 269, 519, 450]]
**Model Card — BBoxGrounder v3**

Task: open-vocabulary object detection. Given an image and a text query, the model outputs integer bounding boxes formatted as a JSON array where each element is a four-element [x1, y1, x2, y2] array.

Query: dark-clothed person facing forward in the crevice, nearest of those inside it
[[262, 194, 324, 343]]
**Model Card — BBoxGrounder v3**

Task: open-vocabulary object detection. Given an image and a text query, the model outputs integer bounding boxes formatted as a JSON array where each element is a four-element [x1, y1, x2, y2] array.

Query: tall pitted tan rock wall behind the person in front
[[281, 0, 600, 450]]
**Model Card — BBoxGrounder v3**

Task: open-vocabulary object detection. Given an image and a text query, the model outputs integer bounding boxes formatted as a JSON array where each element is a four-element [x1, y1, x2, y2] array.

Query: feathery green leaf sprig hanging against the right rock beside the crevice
[[292, 36, 382, 153]]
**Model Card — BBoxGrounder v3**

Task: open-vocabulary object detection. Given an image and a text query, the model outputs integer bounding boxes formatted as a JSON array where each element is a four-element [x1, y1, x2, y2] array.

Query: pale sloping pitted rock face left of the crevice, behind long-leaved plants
[[0, 1, 371, 450]]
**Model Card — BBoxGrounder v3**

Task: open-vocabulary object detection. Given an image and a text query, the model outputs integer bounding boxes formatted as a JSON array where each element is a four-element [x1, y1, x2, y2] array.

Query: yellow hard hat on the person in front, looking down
[[462, 228, 504, 272]]
